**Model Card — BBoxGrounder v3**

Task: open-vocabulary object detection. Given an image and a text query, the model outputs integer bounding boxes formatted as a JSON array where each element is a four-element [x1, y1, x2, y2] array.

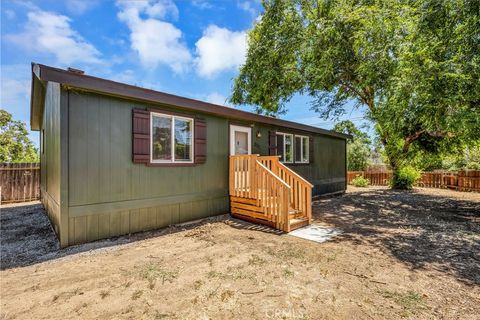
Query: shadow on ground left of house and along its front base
[[0, 202, 262, 270]]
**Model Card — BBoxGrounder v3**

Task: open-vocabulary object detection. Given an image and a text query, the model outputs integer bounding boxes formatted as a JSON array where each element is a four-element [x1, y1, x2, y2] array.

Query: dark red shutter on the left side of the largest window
[[132, 109, 150, 163]]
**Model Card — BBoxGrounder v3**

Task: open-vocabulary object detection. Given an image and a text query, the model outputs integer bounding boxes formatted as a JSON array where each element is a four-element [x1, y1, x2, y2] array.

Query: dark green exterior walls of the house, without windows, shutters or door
[[41, 83, 346, 247]]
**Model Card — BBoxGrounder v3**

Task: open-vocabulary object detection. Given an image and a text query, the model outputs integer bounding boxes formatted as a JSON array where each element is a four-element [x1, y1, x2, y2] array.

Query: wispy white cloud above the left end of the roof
[[6, 10, 101, 64]]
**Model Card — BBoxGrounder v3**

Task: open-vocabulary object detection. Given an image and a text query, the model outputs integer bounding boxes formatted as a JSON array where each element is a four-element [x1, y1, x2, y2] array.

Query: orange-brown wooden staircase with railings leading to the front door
[[229, 154, 313, 232]]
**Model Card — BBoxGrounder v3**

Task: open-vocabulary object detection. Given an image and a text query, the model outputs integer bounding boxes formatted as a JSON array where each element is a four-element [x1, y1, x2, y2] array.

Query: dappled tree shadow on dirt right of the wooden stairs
[[313, 189, 480, 285]]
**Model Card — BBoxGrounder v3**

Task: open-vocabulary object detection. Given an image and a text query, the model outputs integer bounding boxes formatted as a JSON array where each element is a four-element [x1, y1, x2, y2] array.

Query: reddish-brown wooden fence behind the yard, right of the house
[[347, 170, 480, 192]]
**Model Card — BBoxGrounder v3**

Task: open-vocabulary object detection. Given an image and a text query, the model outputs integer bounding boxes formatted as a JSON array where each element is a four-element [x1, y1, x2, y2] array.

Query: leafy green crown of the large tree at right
[[231, 0, 480, 189]]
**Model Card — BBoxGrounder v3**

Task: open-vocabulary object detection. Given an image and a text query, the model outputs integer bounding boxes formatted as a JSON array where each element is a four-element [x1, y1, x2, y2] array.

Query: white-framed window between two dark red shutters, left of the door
[[150, 112, 193, 163]]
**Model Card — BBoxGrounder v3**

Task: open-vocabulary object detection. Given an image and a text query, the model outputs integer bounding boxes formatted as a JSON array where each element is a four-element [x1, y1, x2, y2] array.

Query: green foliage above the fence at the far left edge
[[0, 110, 39, 162]]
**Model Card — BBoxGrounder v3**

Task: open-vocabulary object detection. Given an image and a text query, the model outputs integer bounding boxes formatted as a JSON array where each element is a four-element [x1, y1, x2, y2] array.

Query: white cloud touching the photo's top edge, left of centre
[[117, 0, 192, 73]]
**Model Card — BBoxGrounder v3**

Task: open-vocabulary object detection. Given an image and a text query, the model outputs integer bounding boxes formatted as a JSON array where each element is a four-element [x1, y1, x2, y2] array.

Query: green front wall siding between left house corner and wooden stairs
[[68, 91, 228, 244]]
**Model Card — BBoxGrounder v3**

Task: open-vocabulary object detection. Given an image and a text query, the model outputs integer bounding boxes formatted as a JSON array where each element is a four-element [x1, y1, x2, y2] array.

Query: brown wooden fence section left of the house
[[0, 163, 40, 203]]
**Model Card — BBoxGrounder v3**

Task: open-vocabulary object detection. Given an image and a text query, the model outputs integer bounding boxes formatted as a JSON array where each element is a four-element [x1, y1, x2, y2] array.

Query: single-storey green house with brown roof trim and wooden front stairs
[[30, 63, 348, 247]]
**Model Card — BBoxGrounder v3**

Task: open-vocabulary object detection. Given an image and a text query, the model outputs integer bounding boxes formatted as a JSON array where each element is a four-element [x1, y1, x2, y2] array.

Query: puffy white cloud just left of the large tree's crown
[[195, 25, 247, 78]]
